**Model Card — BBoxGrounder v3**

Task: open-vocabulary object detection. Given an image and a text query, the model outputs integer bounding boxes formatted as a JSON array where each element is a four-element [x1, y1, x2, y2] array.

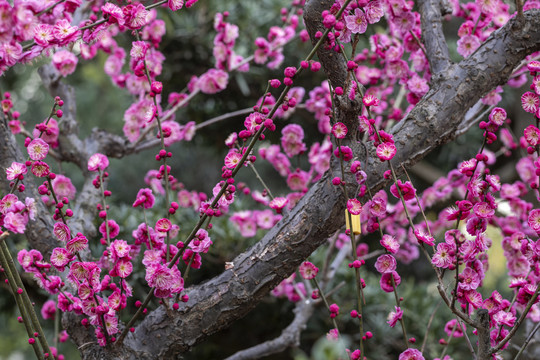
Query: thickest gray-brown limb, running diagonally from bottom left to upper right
[[69, 7, 540, 359]]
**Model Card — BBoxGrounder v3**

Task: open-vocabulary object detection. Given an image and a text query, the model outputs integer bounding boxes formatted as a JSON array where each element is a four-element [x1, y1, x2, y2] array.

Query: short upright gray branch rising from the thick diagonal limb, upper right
[[418, 0, 450, 77]]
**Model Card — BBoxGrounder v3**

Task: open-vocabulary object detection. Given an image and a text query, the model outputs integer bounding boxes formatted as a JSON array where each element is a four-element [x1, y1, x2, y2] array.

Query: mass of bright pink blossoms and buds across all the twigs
[[0, 0, 540, 360]]
